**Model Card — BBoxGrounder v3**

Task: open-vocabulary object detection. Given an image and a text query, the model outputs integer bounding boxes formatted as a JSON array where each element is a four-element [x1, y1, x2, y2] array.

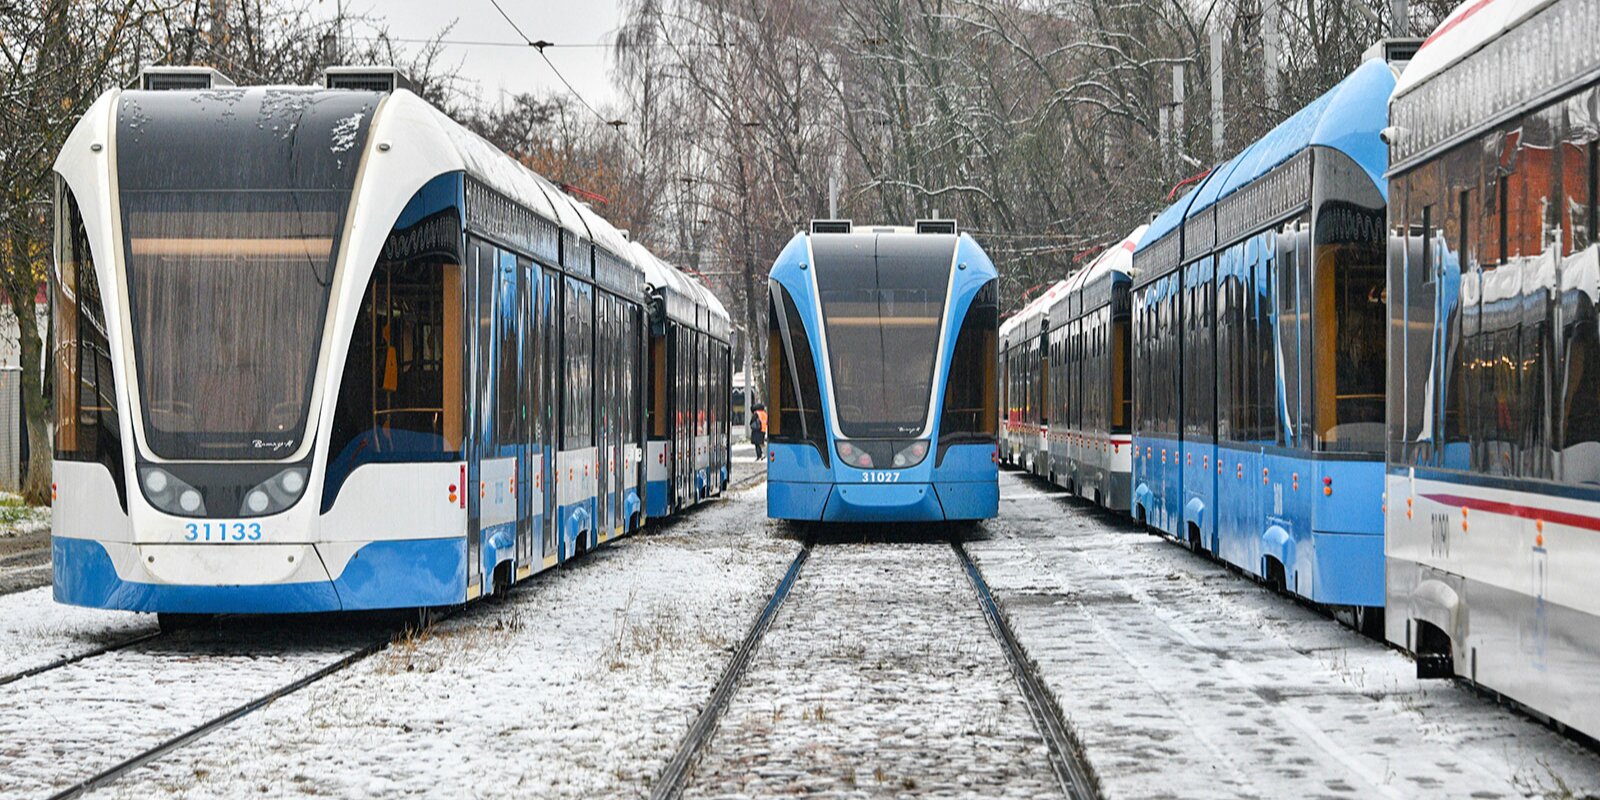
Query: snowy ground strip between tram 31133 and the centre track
[[70, 486, 798, 798]]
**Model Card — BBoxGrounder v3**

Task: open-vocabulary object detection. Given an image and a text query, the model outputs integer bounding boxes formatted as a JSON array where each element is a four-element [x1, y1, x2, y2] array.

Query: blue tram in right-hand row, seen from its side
[[1131, 59, 1397, 626]]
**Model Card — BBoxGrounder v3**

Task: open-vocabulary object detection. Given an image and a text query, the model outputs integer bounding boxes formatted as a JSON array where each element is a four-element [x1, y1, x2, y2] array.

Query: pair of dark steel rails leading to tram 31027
[[650, 531, 1099, 800]]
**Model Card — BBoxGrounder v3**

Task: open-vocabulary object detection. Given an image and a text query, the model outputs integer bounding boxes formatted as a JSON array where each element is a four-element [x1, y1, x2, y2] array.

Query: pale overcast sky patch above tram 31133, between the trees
[[317, 0, 621, 107]]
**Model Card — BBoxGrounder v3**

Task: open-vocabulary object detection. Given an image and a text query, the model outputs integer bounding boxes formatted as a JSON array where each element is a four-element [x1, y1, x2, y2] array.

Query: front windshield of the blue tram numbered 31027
[[811, 234, 955, 438]]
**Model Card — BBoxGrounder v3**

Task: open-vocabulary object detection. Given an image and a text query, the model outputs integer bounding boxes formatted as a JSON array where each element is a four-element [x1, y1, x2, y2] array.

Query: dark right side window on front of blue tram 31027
[[939, 280, 985, 453]]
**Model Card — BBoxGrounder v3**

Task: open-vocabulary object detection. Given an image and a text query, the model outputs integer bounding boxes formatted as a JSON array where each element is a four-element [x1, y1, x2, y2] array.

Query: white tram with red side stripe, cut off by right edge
[[1386, 0, 1600, 738]]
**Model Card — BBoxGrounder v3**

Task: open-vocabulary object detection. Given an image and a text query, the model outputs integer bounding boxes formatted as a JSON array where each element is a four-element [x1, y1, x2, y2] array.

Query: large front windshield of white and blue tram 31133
[[117, 90, 376, 461]]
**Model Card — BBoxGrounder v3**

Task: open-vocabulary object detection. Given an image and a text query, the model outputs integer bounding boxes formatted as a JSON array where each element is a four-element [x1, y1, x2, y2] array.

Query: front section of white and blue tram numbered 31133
[[50, 70, 728, 614]]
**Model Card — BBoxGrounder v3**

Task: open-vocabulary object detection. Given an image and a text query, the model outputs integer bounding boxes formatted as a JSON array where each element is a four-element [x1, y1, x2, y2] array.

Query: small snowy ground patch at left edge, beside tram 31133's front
[[0, 587, 155, 678]]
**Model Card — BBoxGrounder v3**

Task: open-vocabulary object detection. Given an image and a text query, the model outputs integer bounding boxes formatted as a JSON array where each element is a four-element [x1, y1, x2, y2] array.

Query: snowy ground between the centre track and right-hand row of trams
[[968, 474, 1600, 798]]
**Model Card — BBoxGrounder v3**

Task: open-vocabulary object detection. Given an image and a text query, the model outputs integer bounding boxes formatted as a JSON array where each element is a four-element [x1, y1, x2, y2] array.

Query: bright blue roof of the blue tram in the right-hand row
[[1134, 59, 1395, 286]]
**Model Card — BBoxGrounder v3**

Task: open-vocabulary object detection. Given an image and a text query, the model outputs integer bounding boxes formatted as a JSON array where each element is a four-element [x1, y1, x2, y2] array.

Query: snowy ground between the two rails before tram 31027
[[685, 531, 1059, 797]]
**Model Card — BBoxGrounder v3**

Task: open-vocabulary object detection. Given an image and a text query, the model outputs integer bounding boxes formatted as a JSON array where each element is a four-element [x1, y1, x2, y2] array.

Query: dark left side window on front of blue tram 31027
[[766, 283, 829, 464]]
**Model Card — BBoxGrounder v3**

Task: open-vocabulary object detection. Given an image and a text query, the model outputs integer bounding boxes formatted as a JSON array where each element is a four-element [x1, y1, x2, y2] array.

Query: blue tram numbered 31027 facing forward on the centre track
[[766, 219, 1000, 522]]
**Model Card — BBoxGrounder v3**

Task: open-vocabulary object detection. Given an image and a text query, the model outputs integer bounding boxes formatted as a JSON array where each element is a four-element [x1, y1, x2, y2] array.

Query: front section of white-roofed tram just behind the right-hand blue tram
[[1043, 226, 1146, 510]]
